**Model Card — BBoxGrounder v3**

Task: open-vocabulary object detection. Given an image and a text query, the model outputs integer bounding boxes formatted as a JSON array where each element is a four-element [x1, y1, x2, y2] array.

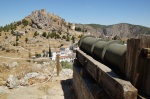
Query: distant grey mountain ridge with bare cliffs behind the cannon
[[76, 23, 150, 37]]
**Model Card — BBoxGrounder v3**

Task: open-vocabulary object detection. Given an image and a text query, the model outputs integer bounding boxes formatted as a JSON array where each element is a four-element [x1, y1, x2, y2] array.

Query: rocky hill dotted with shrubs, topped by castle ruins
[[0, 9, 82, 50]]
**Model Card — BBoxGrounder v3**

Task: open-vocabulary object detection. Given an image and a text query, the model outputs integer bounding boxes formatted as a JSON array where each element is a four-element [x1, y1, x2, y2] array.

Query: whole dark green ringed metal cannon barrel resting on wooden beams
[[78, 36, 127, 73]]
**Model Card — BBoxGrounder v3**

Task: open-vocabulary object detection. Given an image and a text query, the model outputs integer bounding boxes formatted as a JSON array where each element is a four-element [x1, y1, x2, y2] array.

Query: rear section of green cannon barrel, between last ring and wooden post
[[103, 43, 127, 73]]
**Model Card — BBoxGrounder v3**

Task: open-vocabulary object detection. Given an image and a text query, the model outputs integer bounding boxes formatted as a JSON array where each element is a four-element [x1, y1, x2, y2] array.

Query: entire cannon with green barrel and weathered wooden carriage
[[73, 35, 150, 99]]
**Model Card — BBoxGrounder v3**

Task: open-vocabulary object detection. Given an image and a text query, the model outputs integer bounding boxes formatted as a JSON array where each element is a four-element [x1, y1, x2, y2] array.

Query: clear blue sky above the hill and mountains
[[0, 0, 150, 27]]
